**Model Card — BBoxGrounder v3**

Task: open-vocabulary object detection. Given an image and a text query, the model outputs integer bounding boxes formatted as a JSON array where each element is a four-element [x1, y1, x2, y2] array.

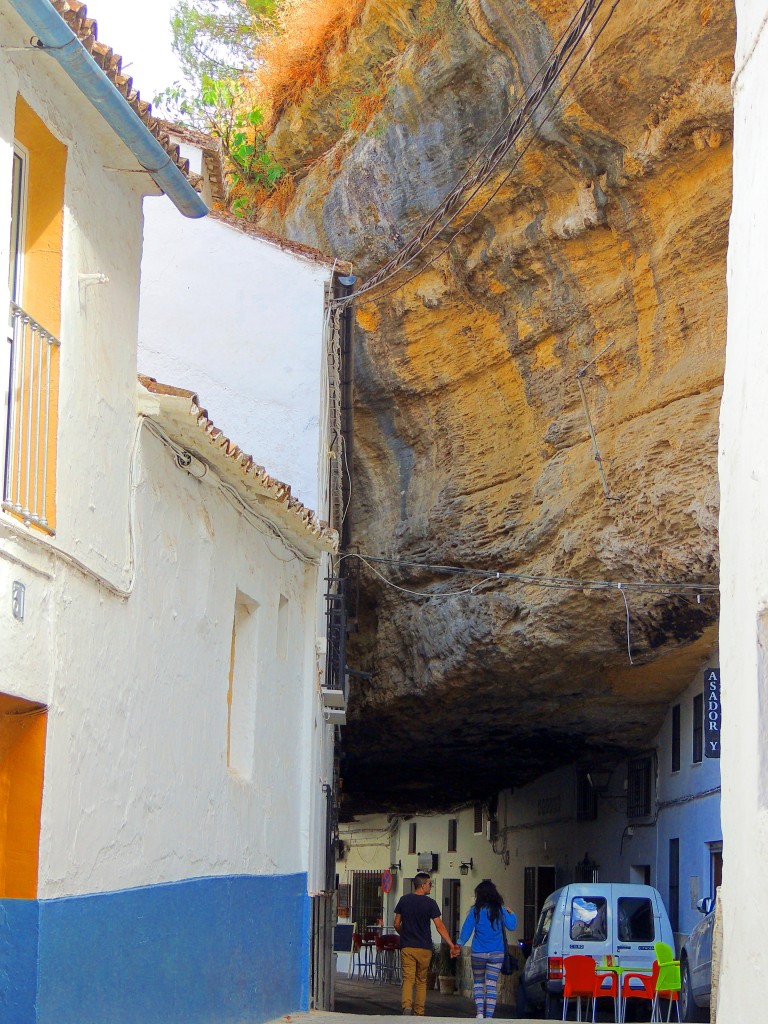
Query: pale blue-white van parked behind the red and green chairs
[[522, 882, 675, 1020]]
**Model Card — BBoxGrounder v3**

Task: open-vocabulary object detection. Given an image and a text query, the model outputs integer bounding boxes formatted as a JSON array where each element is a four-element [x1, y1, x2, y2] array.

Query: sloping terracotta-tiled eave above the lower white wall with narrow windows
[[138, 374, 339, 555]]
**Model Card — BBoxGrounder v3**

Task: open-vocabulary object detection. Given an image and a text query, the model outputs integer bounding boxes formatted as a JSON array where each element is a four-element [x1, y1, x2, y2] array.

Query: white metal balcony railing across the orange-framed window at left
[[3, 302, 60, 535]]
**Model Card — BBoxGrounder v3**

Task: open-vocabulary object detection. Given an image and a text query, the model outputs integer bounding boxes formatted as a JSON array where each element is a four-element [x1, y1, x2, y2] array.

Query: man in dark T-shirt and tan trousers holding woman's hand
[[394, 871, 460, 1017]]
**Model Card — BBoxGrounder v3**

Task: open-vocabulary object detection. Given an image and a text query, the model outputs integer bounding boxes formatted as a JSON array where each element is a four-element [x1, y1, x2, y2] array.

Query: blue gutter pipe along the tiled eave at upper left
[[10, 0, 208, 217]]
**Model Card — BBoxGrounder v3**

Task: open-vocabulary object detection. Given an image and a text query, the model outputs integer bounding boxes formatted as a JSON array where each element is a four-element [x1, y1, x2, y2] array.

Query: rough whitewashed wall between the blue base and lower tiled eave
[[40, 431, 316, 897]]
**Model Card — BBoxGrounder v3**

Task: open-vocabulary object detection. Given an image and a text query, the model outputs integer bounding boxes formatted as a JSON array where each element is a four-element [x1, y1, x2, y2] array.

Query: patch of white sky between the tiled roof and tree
[[88, 0, 181, 102]]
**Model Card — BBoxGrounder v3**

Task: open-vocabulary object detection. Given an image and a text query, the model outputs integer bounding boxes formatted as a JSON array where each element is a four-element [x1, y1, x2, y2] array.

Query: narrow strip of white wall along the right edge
[[718, 0, 768, 1024]]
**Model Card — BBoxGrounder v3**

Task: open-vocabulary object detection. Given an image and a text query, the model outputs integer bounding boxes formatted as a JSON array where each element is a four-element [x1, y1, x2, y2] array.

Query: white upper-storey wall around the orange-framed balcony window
[[0, 8, 150, 720]]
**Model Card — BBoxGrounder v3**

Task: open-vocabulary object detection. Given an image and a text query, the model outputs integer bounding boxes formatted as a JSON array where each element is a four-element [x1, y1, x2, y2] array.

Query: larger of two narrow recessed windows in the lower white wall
[[226, 591, 259, 778]]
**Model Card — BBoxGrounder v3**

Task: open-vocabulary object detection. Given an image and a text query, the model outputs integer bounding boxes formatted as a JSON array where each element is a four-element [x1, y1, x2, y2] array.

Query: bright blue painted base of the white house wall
[[0, 874, 309, 1024]]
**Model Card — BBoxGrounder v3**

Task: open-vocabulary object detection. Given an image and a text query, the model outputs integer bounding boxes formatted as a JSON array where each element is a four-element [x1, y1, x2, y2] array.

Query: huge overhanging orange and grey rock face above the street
[[263, 0, 735, 811]]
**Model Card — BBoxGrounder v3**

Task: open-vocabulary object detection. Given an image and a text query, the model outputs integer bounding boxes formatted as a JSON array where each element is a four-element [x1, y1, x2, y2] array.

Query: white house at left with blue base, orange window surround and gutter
[[0, 0, 337, 1024]]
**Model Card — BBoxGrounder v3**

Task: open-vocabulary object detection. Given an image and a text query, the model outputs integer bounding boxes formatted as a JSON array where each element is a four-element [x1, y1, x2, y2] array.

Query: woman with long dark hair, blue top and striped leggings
[[458, 881, 517, 1020]]
